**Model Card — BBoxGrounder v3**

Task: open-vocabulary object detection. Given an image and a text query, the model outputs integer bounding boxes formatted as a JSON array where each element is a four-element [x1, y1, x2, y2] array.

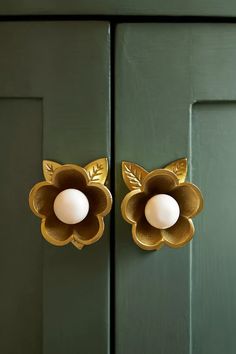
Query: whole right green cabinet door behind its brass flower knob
[[115, 23, 236, 354]]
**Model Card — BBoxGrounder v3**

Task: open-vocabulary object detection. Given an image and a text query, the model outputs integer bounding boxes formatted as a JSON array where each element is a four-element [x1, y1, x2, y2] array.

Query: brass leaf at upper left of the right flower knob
[[122, 161, 148, 190]]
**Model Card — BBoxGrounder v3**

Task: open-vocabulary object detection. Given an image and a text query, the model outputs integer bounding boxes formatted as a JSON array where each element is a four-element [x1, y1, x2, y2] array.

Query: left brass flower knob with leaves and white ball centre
[[29, 158, 112, 249]]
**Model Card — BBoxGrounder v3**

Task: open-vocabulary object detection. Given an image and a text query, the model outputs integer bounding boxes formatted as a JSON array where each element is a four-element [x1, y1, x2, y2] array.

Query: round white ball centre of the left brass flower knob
[[53, 188, 89, 224]]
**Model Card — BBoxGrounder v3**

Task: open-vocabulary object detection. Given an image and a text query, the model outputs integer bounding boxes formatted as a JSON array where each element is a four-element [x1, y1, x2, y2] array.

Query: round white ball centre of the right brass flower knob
[[145, 194, 180, 229]]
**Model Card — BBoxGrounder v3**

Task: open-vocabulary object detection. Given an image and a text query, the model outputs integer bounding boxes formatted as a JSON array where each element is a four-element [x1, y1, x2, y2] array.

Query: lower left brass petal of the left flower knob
[[41, 214, 73, 246]]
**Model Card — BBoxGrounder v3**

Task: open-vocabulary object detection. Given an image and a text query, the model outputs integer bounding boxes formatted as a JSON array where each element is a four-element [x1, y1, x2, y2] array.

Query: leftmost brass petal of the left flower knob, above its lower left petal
[[29, 182, 59, 218]]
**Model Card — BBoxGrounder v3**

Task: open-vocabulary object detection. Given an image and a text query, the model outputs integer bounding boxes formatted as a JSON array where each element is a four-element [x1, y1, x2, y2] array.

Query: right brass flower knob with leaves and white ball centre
[[121, 159, 203, 250]]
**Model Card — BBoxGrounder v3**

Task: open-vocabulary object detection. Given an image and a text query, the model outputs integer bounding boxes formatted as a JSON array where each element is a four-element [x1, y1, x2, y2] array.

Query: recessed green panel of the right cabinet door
[[192, 101, 236, 354]]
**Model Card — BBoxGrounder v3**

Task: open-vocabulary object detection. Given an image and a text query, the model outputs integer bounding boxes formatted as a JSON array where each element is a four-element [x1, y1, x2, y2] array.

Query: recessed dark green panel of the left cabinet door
[[0, 99, 43, 354]]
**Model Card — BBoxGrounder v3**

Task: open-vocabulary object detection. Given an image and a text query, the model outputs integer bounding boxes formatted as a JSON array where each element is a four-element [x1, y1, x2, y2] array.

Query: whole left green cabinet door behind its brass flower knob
[[0, 22, 110, 354]]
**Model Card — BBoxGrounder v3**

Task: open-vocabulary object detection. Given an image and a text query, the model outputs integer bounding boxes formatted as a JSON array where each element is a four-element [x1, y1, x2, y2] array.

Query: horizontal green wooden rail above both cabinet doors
[[0, 0, 236, 17]]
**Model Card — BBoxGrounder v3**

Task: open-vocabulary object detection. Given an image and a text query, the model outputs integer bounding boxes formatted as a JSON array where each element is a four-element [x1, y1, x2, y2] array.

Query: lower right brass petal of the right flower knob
[[161, 216, 194, 248]]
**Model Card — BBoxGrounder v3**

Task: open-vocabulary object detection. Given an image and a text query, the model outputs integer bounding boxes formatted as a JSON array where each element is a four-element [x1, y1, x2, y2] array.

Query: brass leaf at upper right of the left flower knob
[[85, 158, 108, 184]]
